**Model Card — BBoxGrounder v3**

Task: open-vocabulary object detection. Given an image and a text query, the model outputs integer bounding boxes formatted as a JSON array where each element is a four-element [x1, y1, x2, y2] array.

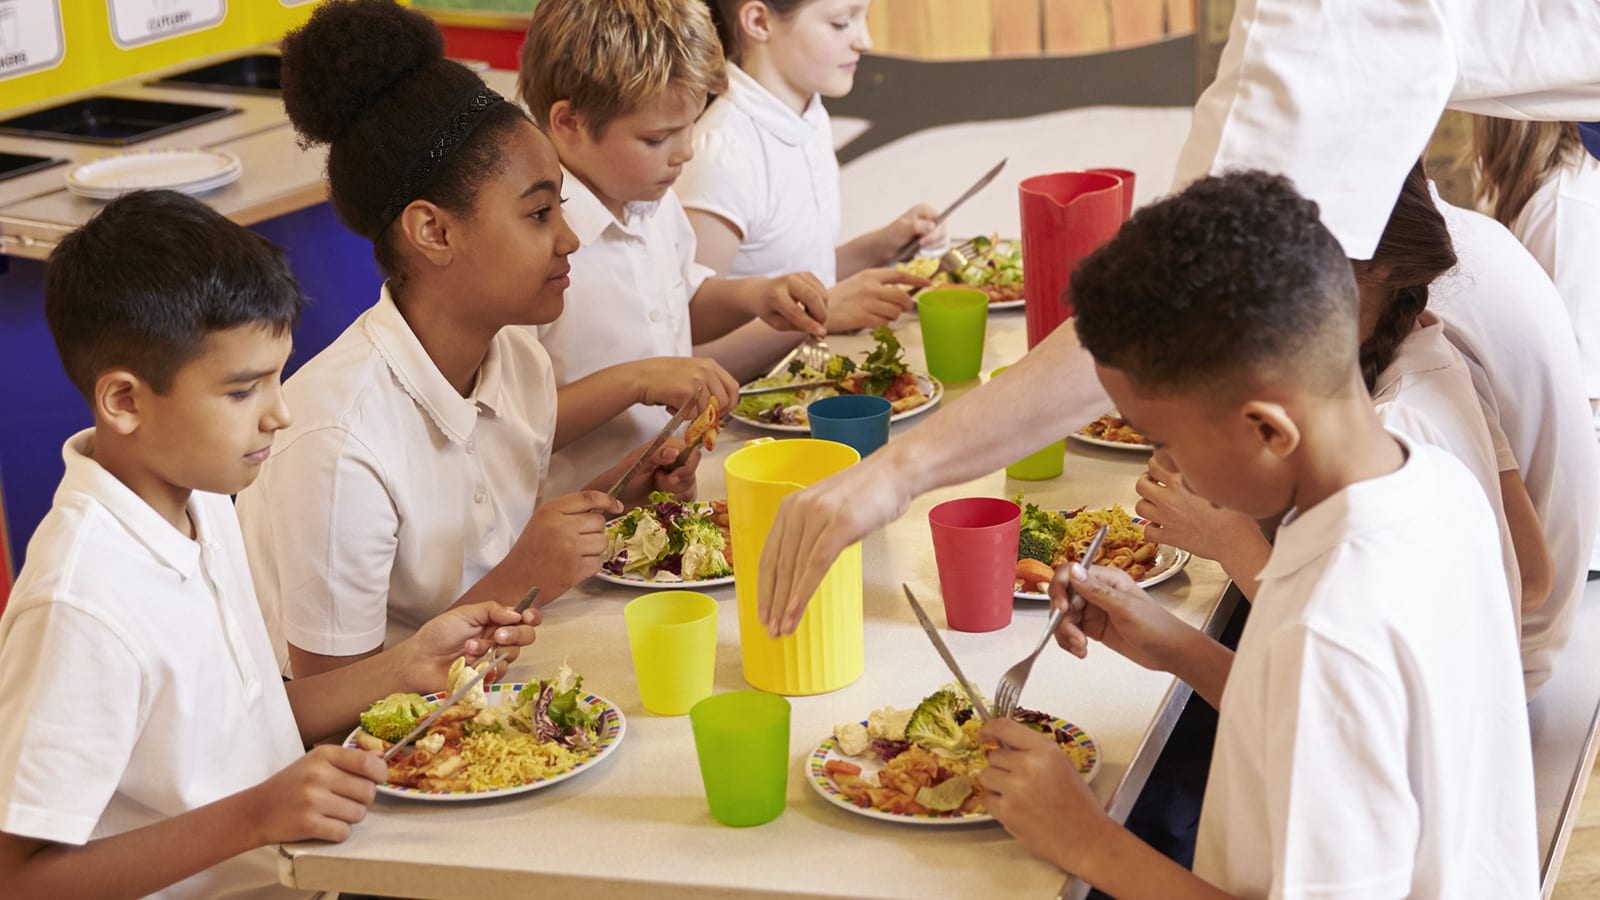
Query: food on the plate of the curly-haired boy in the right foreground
[[822, 685, 1093, 815]]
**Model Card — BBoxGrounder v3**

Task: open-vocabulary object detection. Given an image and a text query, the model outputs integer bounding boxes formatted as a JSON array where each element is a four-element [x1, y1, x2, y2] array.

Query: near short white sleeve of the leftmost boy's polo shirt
[[0, 604, 149, 844]]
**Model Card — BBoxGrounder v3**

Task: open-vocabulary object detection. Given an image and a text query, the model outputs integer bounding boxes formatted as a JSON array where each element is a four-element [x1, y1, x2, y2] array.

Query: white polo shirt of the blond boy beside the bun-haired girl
[[539, 171, 712, 496]]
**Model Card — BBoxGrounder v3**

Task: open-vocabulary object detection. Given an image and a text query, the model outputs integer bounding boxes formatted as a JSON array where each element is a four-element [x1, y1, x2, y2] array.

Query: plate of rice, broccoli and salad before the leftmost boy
[[344, 660, 627, 802]]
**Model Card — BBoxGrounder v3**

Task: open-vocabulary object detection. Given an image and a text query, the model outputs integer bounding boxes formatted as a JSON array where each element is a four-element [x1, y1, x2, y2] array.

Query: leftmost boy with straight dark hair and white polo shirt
[[0, 192, 538, 900]]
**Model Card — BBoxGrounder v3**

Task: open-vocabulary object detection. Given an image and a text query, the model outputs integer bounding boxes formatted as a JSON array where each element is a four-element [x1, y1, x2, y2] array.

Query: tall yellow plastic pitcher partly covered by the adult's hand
[[725, 437, 866, 695]]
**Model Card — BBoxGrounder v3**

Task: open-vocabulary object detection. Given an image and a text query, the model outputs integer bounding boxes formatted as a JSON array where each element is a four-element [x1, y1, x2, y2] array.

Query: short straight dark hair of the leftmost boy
[[45, 191, 306, 404]]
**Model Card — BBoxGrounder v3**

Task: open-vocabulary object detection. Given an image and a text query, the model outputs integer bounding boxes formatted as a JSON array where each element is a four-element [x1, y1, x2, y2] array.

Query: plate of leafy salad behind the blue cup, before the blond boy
[[733, 325, 944, 434]]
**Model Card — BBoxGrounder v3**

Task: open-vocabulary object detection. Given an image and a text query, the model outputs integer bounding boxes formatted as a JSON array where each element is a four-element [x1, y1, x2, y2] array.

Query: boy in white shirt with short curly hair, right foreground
[[979, 173, 1538, 898]]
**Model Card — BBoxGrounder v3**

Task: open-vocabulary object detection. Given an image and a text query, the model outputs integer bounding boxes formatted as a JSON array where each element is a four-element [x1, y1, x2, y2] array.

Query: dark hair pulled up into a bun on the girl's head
[[283, 0, 528, 280]]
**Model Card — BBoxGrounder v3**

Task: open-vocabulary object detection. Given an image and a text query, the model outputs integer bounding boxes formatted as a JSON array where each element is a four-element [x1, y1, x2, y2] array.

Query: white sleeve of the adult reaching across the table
[[1173, 0, 1456, 259]]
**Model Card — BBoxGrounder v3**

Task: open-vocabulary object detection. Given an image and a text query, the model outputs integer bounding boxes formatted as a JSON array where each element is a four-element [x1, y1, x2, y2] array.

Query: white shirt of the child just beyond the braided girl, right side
[[1427, 192, 1600, 698]]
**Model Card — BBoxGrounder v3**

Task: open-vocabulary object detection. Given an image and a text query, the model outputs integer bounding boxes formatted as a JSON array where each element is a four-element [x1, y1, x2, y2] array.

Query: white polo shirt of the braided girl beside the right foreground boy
[[1373, 312, 1522, 614]]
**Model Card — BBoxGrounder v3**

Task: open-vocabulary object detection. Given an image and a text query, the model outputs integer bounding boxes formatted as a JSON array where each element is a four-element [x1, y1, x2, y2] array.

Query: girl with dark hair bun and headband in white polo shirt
[[237, 0, 707, 676]]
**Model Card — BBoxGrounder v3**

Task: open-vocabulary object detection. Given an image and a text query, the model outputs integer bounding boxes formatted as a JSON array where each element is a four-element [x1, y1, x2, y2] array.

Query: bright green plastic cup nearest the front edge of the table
[[690, 690, 789, 826]]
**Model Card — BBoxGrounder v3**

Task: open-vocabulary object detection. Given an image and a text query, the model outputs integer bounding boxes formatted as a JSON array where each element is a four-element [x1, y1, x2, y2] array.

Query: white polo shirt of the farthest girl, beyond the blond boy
[[677, 64, 840, 285]]
